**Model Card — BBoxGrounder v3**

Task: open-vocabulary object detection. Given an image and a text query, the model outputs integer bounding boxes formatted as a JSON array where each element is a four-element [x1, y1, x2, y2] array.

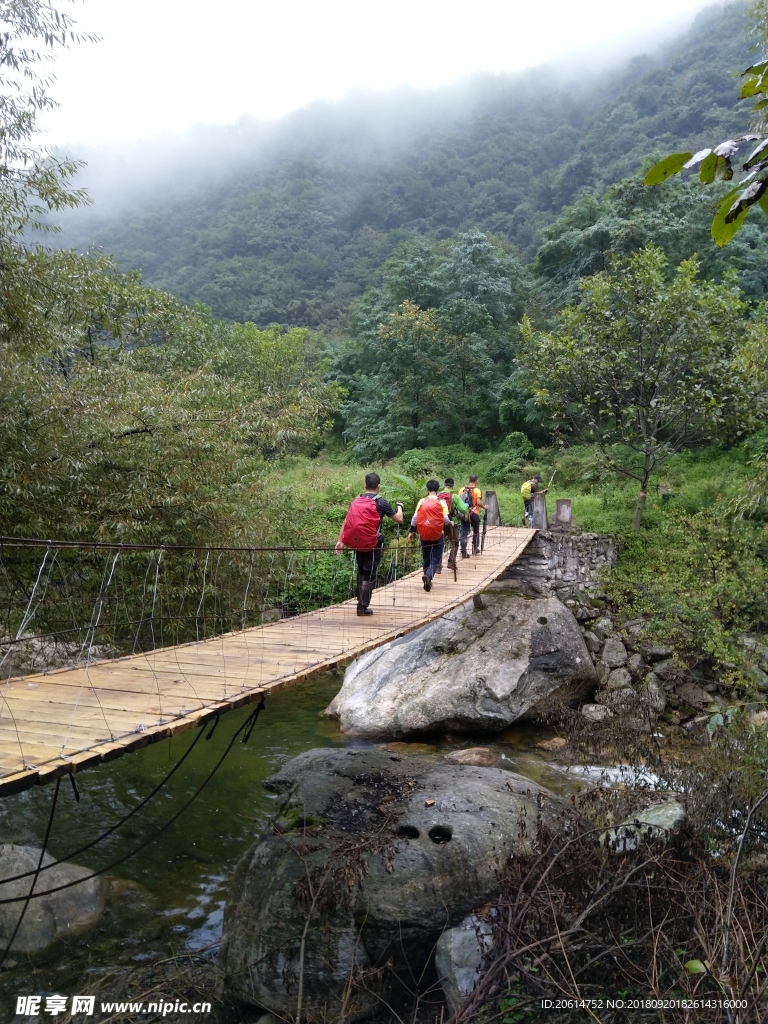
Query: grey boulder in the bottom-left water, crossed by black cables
[[0, 843, 106, 953]]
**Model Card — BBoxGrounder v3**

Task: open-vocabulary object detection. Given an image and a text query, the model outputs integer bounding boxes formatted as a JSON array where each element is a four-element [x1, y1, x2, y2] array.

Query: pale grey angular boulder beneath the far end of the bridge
[[326, 591, 597, 739]]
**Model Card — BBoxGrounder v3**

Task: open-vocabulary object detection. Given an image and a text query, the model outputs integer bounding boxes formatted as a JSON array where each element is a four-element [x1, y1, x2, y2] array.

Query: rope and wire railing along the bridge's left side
[[0, 527, 518, 679]]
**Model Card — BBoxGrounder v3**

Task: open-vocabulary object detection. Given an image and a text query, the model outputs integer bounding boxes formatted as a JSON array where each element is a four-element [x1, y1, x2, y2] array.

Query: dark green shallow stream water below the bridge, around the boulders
[[0, 674, 575, 1020]]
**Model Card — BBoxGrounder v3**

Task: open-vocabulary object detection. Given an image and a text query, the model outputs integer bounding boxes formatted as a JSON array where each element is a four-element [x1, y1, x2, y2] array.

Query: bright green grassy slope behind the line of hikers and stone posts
[[255, 445, 751, 544]]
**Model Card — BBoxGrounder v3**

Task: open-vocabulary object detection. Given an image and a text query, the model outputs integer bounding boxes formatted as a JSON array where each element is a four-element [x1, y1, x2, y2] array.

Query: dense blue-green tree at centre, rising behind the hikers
[[335, 231, 526, 460]]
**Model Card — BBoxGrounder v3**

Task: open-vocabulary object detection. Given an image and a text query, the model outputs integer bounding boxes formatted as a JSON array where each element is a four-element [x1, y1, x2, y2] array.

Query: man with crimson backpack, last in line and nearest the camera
[[335, 473, 402, 615]]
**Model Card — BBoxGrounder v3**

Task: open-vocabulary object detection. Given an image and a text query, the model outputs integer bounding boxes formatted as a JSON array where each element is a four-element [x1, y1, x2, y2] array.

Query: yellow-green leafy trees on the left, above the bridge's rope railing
[[0, 272, 338, 543]]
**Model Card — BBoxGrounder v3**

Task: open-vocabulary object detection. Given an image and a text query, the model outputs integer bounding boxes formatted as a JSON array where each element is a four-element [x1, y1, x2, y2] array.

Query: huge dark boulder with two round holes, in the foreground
[[221, 750, 569, 1020]]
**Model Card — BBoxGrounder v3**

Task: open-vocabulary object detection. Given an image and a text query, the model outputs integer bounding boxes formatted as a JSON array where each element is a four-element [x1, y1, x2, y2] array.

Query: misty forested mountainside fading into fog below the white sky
[[58, 3, 752, 328]]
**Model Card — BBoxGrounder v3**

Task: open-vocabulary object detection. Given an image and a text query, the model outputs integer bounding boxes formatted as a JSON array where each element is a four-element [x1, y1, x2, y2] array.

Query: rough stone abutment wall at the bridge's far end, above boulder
[[499, 530, 616, 601]]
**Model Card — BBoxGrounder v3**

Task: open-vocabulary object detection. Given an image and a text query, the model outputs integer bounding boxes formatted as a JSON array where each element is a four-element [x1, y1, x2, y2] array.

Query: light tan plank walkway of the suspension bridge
[[0, 526, 534, 796]]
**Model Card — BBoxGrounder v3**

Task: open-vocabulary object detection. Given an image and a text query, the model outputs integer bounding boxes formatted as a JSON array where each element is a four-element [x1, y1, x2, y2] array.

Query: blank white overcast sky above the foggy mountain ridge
[[40, 0, 720, 144]]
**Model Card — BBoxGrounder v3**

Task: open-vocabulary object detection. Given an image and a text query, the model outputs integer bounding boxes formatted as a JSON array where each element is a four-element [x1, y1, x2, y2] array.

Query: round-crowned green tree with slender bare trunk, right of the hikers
[[519, 248, 751, 526]]
